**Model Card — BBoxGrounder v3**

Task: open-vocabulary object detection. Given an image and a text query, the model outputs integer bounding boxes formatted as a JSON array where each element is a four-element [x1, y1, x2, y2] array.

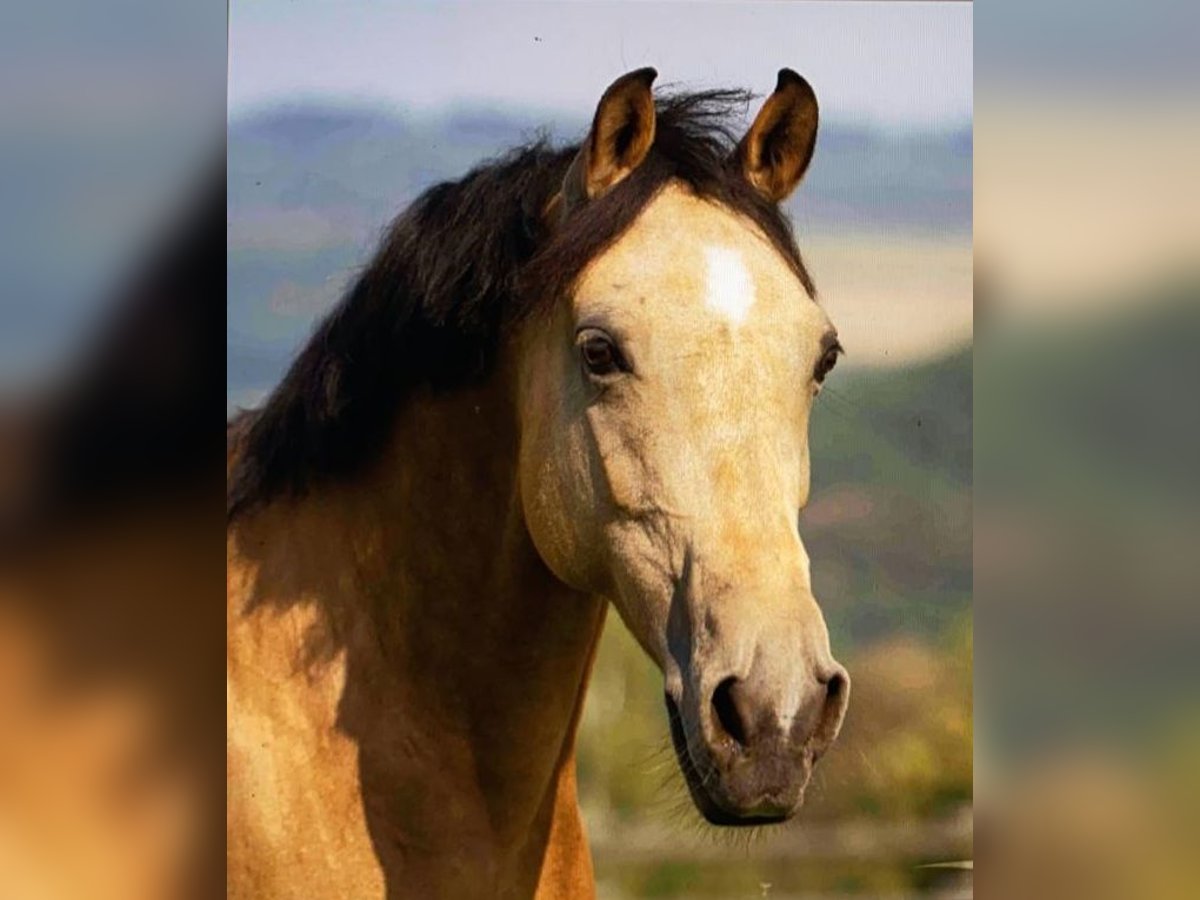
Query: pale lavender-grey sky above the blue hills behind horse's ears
[[229, 0, 973, 127]]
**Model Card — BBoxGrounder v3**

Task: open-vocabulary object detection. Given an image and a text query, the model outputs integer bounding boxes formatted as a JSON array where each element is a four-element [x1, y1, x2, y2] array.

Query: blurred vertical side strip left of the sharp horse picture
[[0, 0, 227, 898]]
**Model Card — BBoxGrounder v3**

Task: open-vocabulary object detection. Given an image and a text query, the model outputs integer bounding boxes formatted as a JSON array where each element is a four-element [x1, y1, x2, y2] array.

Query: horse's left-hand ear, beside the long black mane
[[563, 67, 659, 206]]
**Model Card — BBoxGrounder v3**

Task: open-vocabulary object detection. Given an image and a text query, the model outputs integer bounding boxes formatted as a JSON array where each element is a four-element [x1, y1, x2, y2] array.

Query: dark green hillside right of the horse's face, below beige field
[[800, 348, 972, 649]]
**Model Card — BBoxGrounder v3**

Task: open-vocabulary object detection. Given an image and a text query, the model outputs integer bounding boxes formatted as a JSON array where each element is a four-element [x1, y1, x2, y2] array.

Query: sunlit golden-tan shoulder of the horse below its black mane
[[227, 518, 384, 899]]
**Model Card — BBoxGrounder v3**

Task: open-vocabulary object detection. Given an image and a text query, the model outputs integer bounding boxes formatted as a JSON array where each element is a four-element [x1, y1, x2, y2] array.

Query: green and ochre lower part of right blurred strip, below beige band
[[976, 278, 1200, 900]]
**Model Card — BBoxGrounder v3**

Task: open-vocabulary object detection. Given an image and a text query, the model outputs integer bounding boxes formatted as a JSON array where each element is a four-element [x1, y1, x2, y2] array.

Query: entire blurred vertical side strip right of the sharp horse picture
[[974, 0, 1200, 900]]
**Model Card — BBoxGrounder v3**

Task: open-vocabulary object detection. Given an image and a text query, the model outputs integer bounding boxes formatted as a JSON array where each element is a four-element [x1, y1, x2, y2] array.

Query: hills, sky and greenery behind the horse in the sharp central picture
[[227, 2, 973, 898]]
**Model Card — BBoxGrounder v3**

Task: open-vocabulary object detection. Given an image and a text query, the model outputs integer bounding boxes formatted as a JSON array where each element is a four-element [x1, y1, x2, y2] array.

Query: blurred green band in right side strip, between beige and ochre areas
[[976, 278, 1200, 757]]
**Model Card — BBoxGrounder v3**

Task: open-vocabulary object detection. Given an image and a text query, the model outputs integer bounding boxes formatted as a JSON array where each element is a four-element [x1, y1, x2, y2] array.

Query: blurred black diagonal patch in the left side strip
[[4, 154, 226, 540]]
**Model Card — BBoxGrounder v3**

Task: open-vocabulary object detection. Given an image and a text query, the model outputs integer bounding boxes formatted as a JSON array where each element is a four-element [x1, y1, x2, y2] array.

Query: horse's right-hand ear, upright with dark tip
[[736, 68, 817, 203]]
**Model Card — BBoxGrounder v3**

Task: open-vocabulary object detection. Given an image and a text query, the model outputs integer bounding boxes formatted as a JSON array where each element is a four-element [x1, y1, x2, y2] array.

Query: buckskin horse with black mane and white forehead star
[[227, 68, 850, 898]]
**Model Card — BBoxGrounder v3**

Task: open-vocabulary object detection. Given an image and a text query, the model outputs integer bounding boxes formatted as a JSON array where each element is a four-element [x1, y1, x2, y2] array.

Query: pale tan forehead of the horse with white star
[[581, 185, 808, 325]]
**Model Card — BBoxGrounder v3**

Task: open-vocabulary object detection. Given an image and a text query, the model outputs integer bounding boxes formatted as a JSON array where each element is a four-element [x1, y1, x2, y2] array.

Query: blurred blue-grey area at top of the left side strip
[[0, 0, 226, 396]]
